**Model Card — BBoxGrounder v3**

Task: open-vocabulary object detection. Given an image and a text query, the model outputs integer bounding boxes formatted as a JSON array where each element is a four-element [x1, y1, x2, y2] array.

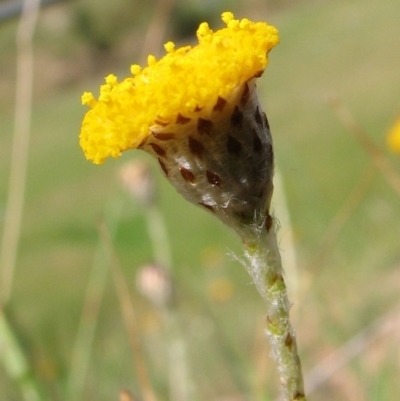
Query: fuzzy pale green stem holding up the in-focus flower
[[245, 221, 306, 401]]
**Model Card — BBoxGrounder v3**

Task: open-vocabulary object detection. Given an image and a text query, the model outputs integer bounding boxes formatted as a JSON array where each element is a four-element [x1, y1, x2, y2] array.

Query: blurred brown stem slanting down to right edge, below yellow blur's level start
[[330, 97, 400, 195]]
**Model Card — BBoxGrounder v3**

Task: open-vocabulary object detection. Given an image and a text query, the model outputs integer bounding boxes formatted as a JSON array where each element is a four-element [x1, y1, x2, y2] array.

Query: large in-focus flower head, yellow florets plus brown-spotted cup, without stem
[[80, 12, 279, 238]]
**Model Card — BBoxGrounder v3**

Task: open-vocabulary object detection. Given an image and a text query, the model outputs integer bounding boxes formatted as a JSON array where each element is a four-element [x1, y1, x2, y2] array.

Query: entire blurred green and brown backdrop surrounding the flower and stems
[[0, 0, 400, 401]]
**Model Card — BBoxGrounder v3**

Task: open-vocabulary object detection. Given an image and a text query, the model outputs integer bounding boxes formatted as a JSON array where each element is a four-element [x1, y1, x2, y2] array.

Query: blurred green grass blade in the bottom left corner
[[0, 312, 41, 401]]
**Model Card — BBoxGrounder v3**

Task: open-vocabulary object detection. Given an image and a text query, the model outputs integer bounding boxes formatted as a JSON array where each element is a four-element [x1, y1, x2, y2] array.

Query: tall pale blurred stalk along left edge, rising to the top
[[0, 0, 40, 305]]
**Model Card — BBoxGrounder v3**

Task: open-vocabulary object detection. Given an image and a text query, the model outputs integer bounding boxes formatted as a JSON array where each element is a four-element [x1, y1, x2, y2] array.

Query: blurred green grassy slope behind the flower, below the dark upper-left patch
[[0, 0, 400, 401]]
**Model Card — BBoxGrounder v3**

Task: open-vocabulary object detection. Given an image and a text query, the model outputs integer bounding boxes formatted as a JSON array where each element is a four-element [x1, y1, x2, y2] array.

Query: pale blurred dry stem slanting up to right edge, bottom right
[[305, 305, 400, 394]]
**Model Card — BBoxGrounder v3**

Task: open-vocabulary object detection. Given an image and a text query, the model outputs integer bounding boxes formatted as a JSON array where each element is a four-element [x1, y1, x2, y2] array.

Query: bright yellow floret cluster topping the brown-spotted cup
[[80, 12, 279, 164]]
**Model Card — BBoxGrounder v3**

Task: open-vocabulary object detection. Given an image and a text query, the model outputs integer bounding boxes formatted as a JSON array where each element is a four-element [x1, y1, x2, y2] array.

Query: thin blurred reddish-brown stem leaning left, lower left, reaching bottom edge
[[99, 221, 157, 401]]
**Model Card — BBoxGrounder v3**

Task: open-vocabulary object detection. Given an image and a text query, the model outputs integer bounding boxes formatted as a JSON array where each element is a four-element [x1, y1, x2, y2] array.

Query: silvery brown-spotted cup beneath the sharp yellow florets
[[140, 79, 274, 237]]
